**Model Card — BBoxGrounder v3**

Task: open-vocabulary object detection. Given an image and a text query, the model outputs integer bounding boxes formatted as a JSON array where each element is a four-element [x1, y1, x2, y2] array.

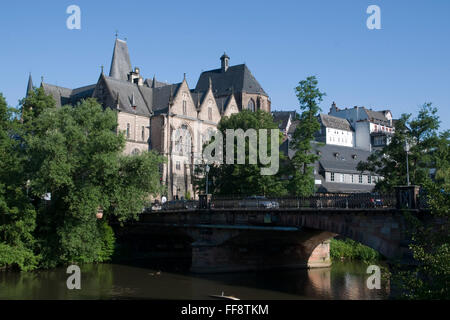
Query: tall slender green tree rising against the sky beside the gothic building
[[288, 76, 325, 196]]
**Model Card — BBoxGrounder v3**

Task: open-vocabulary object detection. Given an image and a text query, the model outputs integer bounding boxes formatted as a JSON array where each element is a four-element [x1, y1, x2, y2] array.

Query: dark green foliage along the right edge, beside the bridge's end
[[359, 103, 450, 299]]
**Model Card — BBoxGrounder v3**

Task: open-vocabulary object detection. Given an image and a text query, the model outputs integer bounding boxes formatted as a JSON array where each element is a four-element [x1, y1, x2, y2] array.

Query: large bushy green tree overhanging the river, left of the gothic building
[[25, 99, 163, 267]]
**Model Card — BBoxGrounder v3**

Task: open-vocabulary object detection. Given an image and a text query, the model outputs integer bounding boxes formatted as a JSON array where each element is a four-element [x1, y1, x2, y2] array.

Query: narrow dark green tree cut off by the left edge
[[0, 94, 38, 270]]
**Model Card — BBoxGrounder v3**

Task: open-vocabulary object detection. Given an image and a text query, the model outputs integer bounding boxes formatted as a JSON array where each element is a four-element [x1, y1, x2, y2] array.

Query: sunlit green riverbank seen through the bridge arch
[[330, 238, 383, 263]]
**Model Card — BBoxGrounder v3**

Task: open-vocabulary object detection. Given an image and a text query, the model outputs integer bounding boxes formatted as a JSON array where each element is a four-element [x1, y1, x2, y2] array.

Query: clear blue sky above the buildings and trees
[[0, 0, 450, 129]]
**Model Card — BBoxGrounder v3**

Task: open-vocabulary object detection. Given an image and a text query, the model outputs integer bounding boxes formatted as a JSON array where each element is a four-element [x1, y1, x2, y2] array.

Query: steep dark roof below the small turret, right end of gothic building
[[195, 64, 267, 96]]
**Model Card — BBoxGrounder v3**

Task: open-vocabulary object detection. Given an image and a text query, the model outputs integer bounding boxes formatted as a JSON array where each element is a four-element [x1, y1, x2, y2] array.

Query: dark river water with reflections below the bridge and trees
[[0, 261, 389, 300]]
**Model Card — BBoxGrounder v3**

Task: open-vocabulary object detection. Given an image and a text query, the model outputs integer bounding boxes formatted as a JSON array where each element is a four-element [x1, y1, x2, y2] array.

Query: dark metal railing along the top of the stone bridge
[[211, 193, 397, 209]]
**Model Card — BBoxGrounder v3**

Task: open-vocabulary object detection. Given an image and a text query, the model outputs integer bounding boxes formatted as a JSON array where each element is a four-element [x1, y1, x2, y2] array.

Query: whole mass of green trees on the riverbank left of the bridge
[[0, 88, 163, 270]]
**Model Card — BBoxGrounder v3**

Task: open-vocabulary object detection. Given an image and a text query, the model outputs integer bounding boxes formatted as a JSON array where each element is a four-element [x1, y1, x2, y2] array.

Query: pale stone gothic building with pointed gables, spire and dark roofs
[[27, 39, 271, 199]]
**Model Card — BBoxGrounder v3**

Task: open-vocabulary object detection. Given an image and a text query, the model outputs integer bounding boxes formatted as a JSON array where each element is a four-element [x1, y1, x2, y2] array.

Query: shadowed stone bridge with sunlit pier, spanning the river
[[118, 208, 428, 272]]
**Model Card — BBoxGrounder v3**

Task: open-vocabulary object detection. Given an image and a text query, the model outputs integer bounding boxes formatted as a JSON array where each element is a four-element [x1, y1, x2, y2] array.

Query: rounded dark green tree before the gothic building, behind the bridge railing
[[195, 110, 286, 196]]
